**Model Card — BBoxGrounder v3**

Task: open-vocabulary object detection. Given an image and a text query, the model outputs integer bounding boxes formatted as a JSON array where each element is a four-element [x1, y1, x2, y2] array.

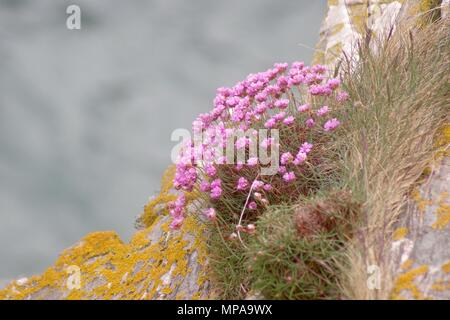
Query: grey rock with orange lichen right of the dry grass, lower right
[[392, 157, 450, 299]]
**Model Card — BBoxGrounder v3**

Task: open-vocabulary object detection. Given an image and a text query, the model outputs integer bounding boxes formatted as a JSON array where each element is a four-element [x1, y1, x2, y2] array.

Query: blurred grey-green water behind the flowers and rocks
[[0, 0, 326, 281]]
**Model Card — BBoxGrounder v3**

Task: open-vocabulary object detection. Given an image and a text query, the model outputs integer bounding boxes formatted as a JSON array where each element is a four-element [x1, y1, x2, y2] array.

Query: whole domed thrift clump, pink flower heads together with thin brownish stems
[[169, 62, 348, 234]]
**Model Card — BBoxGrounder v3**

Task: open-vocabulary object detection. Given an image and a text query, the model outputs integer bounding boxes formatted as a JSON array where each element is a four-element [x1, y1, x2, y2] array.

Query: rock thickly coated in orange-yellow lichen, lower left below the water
[[0, 217, 207, 299]]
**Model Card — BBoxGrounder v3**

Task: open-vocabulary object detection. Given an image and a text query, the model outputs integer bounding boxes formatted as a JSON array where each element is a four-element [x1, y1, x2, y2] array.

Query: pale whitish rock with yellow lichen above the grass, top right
[[313, 0, 449, 67]]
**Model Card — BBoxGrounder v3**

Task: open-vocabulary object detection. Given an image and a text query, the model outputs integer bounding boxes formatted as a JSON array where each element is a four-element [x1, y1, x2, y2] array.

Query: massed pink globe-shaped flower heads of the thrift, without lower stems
[[170, 62, 348, 229]]
